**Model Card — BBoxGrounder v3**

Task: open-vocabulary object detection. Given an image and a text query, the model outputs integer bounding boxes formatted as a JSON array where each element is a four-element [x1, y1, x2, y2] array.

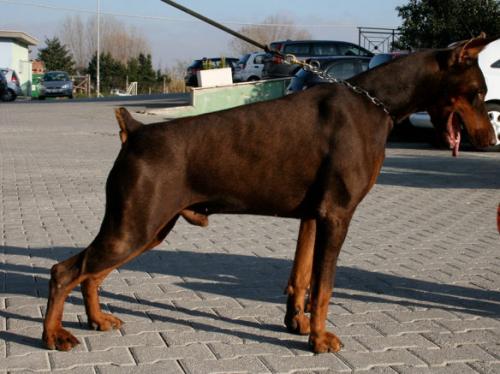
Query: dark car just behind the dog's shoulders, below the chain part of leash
[[286, 56, 370, 94]]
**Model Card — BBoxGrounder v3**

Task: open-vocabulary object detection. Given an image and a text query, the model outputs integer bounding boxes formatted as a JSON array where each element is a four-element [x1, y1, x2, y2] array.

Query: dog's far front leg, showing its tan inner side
[[285, 219, 316, 335]]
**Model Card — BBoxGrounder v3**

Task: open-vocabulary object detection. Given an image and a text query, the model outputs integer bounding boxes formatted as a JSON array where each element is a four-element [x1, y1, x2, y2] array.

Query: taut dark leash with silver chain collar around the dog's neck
[[161, 0, 392, 118]]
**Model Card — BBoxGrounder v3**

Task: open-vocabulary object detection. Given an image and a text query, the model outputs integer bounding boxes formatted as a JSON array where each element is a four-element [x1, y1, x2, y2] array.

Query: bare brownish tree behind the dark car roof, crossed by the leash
[[230, 15, 311, 55]]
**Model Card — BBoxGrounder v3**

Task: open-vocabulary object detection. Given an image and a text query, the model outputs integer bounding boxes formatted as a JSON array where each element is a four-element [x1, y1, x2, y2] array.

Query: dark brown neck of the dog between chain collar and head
[[349, 52, 440, 122]]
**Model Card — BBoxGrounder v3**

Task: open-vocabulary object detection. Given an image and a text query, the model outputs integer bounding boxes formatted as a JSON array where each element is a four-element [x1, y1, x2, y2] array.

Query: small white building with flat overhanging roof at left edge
[[0, 30, 38, 95]]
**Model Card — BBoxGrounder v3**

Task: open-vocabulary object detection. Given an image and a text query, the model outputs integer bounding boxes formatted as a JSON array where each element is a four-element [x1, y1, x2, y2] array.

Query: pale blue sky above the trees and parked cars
[[0, 0, 407, 68]]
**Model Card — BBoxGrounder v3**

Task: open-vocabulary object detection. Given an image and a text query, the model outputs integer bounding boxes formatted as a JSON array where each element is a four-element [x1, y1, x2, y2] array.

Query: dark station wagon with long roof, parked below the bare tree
[[262, 40, 373, 79]]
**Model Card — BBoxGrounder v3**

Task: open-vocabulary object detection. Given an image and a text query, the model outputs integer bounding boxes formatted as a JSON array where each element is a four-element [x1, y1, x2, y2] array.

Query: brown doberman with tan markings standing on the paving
[[43, 35, 495, 352]]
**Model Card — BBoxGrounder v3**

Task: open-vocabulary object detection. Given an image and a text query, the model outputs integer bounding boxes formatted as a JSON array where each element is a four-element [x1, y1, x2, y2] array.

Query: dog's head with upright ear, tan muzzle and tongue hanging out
[[427, 34, 496, 156]]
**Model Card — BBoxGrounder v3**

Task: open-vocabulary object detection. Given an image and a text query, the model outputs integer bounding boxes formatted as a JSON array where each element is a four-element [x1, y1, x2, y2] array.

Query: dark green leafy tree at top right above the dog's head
[[396, 0, 500, 49]]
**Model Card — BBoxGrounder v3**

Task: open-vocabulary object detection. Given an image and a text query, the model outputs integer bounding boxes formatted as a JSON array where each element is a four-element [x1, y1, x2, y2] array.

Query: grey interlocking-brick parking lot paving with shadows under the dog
[[0, 97, 500, 374]]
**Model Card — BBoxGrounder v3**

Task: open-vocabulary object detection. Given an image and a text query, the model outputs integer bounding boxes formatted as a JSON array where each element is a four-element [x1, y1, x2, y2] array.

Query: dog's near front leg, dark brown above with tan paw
[[309, 211, 352, 353]]
